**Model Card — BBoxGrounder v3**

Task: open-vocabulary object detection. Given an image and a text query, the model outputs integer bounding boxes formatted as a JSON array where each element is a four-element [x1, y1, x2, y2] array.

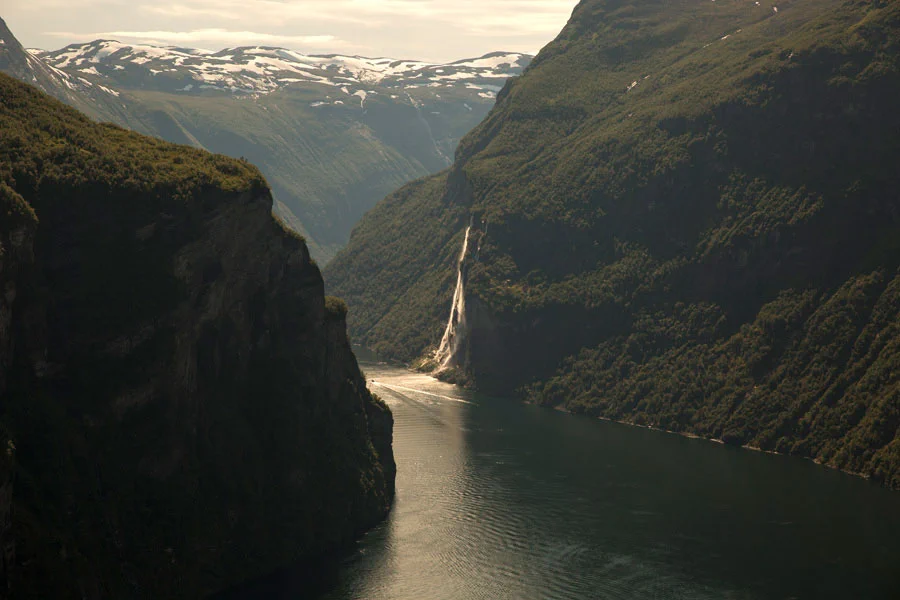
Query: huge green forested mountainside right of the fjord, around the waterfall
[[325, 0, 900, 488]]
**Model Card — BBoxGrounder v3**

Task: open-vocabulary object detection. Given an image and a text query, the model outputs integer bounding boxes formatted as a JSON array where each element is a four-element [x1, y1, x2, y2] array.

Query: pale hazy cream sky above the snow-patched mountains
[[0, 0, 577, 61]]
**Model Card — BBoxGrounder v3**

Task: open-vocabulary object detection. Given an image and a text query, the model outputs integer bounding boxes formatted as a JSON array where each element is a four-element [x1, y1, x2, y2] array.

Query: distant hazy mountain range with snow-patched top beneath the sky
[[0, 20, 531, 261]]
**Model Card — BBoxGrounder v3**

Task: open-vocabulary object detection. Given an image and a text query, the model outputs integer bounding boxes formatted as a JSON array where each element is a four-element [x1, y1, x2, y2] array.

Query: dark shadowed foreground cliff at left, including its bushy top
[[0, 76, 394, 598]]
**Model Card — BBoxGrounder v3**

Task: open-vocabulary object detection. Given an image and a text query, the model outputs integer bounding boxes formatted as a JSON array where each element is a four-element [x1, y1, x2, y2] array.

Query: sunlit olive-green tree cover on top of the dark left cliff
[[0, 75, 265, 204]]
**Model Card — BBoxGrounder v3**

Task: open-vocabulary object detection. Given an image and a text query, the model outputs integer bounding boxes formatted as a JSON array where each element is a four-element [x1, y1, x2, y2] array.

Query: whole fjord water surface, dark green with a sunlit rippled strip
[[225, 363, 900, 600]]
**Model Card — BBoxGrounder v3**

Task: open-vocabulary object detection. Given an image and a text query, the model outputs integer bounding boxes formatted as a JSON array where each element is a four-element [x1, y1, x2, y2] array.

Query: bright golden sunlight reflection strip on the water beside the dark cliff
[[346, 368, 477, 598]]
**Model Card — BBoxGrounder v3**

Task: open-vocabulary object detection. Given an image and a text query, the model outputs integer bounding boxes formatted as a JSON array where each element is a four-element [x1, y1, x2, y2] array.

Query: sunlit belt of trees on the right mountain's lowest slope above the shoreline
[[526, 271, 900, 488]]
